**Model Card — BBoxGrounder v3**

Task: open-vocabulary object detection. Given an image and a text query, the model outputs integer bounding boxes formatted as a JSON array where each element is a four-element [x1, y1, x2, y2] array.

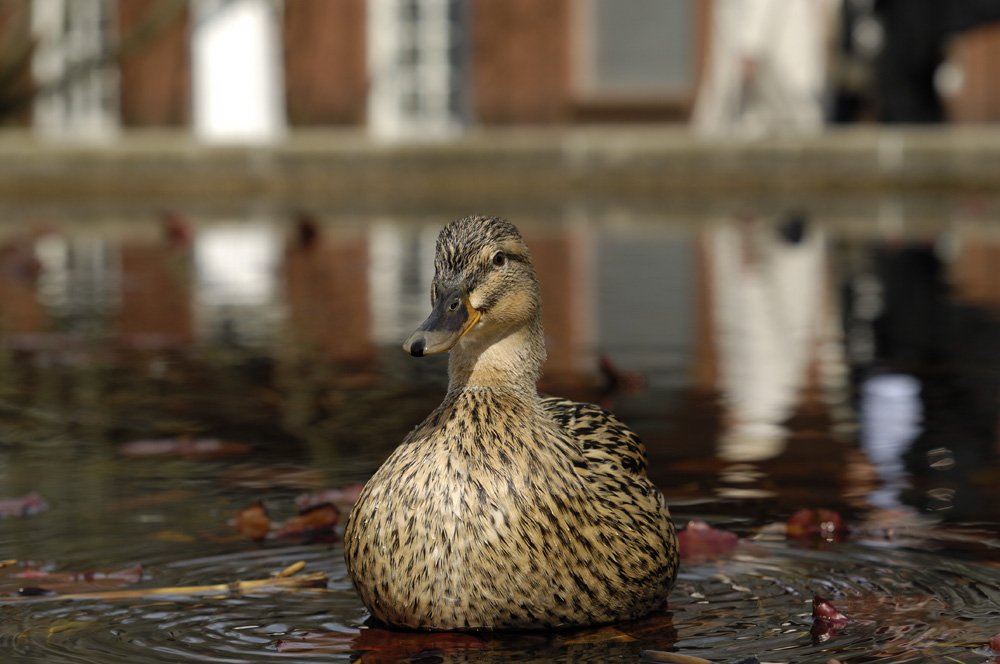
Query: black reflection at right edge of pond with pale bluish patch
[[844, 226, 1000, 516]]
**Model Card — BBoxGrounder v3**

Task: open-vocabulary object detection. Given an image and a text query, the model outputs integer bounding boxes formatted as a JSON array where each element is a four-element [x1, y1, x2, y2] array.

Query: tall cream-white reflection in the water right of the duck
[[705, 213, 831, 462]]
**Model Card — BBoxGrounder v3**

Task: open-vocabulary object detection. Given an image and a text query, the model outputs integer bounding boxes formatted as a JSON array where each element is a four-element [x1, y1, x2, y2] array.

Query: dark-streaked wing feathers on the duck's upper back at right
[[542, 397, 646, 478]]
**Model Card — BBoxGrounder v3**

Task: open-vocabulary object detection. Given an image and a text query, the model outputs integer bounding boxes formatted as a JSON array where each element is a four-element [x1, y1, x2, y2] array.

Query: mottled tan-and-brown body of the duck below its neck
[[347, 391, 677, 629]]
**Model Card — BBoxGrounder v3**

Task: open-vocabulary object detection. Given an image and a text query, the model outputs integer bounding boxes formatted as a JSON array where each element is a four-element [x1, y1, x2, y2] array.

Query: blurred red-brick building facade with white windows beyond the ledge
[[0, 0, 1000, 140]]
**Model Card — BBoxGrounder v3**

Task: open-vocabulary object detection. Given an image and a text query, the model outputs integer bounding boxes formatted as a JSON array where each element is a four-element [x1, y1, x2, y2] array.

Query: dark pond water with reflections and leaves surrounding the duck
[[0, 200, 1000, 663]]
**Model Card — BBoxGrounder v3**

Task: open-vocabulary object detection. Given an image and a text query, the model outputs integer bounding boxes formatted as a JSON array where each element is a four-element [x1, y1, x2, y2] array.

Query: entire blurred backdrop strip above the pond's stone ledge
[[0, 0, 1000, 143]]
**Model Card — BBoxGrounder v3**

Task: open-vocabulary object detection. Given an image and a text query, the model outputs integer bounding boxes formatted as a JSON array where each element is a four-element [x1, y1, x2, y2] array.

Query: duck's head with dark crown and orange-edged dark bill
[[403, 216, 541, 357]]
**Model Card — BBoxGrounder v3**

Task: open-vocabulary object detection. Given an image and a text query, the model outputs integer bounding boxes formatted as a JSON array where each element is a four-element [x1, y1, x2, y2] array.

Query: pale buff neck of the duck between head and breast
[[448, 317, 545, 397]]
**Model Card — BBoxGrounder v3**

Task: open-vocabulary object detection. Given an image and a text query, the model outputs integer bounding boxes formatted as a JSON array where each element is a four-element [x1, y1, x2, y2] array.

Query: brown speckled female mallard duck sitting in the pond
[[344, 216, 677, 630]]
